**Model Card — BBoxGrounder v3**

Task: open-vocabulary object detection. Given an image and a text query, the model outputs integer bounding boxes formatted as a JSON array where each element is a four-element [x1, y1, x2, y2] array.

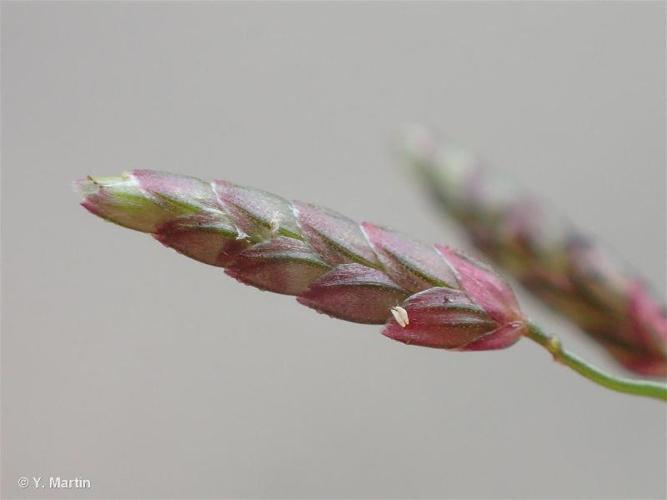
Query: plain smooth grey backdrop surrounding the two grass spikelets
[[2, 2, 666, 498]]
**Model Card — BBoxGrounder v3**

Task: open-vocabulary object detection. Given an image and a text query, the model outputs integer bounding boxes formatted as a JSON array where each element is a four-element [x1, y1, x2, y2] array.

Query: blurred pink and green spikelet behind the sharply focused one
[[404, 128, 667, 377]]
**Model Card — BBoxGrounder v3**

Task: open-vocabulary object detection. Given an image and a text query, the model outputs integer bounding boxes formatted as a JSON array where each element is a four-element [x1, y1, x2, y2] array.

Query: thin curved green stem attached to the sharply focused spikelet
[[526, 323, 667, 401]]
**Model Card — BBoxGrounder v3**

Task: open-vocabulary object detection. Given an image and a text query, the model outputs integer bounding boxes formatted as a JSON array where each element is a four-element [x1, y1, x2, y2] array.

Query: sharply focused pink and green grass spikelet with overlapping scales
[[77, 170, 528, 350]]
